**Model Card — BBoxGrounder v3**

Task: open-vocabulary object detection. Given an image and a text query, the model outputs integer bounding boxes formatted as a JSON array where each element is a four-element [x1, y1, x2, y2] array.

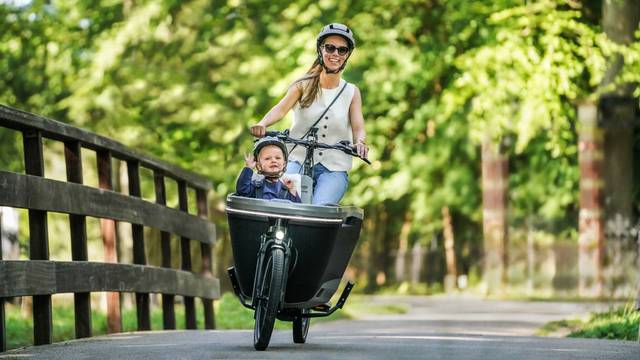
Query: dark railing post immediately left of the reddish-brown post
[[64, 141, 92, 338]]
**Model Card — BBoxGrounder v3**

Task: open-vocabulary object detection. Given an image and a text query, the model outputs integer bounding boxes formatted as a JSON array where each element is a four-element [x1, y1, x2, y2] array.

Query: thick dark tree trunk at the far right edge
[[599, 0, 640, 295]]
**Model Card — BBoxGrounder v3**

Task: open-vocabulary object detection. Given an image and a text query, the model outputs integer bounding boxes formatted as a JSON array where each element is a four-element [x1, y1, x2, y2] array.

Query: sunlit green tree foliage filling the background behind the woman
[[0, 0, 640, 290]]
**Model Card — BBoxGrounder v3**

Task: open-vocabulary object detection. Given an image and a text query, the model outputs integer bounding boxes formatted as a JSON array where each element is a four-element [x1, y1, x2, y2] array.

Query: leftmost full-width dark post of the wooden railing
[[23, 131, 52, 345]]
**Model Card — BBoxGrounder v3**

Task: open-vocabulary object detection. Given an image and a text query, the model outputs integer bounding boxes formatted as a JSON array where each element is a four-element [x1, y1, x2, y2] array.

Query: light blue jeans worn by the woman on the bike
[[287, 161, 349, 205]]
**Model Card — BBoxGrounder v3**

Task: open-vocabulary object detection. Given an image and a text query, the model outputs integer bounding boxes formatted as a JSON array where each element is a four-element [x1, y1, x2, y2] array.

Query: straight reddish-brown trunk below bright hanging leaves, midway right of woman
[[482, 140, 509, 294]]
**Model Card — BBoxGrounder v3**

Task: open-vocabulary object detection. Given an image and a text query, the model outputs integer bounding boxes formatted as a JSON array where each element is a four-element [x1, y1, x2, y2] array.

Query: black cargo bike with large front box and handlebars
[[226, 128, 369, 350]]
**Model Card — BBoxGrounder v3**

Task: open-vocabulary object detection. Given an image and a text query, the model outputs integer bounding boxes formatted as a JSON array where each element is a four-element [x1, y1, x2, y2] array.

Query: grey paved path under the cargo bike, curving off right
[[0, 297, 640, 360]]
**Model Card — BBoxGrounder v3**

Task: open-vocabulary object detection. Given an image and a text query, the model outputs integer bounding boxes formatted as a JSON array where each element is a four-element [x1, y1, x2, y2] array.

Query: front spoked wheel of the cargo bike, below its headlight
[[253, 248, 284, 350]]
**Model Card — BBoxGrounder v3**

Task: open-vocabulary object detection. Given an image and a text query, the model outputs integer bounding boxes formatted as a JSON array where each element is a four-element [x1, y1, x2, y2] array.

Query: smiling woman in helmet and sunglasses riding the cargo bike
[[250, 23, 368, 204]]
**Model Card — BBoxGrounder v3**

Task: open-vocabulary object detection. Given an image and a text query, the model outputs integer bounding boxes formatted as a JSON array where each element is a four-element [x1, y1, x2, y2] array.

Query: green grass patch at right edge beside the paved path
[[538, 305, 640, 340]]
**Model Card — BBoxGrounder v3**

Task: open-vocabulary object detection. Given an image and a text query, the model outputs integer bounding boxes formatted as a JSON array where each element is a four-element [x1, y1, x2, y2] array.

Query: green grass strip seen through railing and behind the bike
[[5, 293, 407, 349]]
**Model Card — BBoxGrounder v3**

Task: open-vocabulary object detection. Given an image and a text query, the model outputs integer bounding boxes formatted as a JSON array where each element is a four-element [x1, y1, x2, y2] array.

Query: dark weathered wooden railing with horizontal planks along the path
[[0, 105, 220, 352]]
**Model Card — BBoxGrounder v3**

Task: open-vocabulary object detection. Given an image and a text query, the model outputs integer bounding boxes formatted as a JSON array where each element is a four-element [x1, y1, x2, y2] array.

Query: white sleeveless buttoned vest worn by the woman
[[288, 79, 355, 171]]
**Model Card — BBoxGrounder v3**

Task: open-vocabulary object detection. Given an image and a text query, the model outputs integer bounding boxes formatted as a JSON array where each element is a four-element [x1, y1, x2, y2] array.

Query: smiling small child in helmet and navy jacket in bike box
[[236, 136, 301, 203]]
